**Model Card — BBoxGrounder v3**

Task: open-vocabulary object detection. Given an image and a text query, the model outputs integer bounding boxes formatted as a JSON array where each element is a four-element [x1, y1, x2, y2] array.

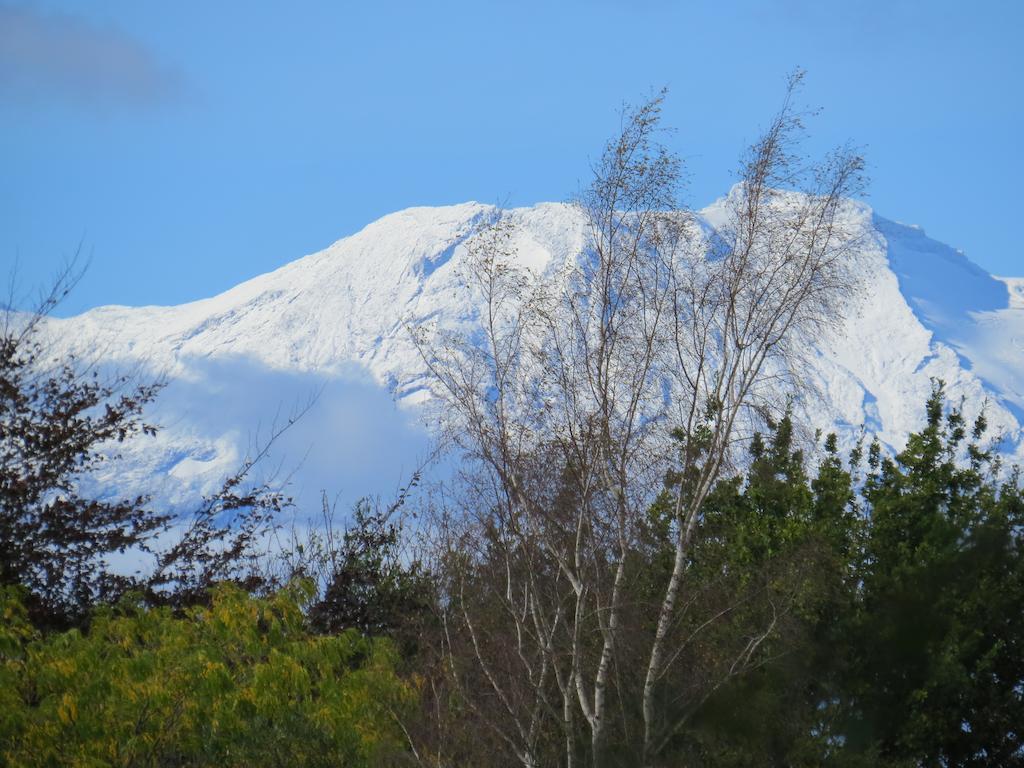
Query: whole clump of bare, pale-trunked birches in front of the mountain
[[407, 74, 862, 767]]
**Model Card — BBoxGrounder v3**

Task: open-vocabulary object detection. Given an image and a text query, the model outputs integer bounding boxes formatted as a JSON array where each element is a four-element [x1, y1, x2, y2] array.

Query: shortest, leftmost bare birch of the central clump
[[414, 216, 562, 766]]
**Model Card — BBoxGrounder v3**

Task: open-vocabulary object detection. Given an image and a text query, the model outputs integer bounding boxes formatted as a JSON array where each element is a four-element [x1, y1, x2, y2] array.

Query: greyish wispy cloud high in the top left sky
[[0, 5, 182, 110]]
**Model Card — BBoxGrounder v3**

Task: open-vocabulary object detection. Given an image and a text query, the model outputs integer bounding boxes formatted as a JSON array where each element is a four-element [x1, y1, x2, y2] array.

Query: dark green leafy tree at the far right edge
[[849, 384, 1024, 766]]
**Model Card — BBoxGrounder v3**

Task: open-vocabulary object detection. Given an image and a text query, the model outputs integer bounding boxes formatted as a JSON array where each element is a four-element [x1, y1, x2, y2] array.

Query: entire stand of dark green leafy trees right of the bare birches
[[654, 391, 1024, 768]]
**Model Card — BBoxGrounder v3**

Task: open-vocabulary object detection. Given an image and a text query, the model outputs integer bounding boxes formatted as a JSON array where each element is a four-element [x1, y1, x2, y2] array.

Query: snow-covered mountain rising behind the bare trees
[[51, 203, 1024, 512]]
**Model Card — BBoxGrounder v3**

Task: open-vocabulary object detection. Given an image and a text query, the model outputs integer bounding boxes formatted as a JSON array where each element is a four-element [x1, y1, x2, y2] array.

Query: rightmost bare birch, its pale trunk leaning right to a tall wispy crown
[[643, 72, 864, 761]]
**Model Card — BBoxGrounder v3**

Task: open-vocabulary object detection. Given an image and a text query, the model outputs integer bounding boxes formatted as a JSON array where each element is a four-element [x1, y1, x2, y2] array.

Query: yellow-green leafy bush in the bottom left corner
[[0, 583, 413, 768]]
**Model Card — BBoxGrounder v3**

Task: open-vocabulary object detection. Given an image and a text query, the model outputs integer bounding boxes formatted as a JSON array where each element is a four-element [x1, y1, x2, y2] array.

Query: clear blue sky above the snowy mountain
[[0, 0, 1024, 314]]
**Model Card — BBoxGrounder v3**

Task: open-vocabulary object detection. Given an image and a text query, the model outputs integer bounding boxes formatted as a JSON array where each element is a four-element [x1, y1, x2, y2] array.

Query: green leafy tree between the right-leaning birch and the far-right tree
[[668, 416, 863, 766]]
